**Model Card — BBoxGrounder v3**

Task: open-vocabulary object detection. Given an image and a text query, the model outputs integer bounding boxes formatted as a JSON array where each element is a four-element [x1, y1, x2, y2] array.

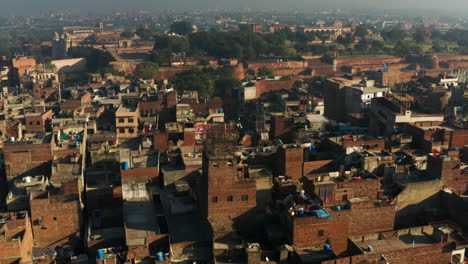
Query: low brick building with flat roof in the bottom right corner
[[322, 223, 467, 264]]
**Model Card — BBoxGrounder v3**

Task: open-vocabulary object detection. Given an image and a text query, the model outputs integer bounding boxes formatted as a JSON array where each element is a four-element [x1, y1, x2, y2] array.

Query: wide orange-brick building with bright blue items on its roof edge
[[284, 196, 396, 254]]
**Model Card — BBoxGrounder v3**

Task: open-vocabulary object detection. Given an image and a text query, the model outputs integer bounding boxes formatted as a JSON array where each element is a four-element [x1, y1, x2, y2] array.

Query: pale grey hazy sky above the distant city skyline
[[0, 0, 468, 15]]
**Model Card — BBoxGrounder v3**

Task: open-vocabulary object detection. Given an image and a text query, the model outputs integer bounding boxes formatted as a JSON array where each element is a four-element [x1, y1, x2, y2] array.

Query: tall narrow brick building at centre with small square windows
[[200, 126, 256, 239]]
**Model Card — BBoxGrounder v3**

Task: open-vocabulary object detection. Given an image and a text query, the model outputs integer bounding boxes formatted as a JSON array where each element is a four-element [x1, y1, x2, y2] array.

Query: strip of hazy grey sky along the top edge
[[0, 0, 468, 18]]
